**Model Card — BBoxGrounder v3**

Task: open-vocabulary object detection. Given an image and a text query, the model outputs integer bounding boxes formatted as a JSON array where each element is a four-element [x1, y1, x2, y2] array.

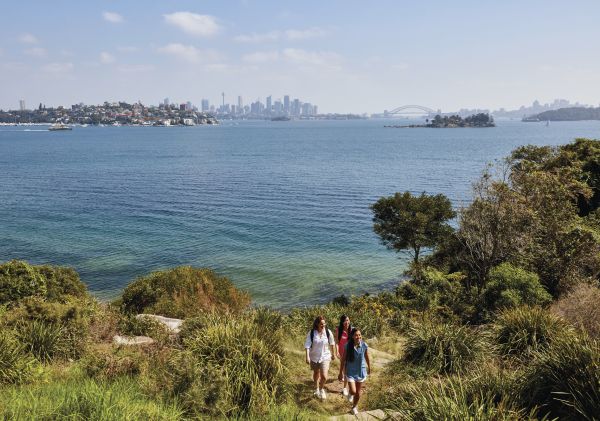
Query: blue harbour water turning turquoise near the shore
[[0, 120, 600, 308]]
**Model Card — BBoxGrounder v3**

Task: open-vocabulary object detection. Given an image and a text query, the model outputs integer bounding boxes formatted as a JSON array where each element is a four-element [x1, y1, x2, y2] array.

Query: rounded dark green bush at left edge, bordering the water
[[0, 260, 87, 304]]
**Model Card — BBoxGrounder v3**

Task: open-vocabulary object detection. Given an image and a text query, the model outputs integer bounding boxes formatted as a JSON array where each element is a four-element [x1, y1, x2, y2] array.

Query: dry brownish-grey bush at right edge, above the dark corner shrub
[[552, 283, 600, 339]]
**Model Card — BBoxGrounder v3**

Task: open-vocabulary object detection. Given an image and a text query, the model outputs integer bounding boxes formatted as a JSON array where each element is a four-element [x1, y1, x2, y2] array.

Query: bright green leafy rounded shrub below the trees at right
[[483, 263, 552, 311]]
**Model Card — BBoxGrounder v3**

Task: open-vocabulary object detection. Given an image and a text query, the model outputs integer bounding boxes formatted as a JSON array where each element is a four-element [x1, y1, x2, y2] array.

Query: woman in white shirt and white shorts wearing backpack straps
[[304, 316, 335, 399]]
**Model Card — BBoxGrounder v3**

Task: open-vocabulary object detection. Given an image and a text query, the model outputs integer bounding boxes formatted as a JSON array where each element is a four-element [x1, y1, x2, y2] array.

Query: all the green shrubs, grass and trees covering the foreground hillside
[[0, 139, 600, 420]]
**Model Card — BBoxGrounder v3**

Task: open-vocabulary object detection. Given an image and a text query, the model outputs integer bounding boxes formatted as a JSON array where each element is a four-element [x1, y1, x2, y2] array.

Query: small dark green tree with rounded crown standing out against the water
[[371, 192, 456, 265]]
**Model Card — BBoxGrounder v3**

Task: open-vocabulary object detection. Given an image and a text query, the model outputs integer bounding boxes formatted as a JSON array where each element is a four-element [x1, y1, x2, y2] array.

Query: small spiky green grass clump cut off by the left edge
[[0, 329, 36, 385]]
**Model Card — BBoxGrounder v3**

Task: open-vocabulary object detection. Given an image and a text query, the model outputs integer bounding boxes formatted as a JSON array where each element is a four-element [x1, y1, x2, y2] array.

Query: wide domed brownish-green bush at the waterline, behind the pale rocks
[[120, 266, 250, 318]]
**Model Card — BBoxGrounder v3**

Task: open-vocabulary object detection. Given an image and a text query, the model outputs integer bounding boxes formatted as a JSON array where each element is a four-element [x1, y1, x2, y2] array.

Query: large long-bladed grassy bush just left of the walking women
[[148, 309, 291, 417]]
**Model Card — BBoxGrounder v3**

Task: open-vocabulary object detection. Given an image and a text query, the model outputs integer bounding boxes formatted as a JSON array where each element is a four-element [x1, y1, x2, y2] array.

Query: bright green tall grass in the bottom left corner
[[0, 379, 182, 421]]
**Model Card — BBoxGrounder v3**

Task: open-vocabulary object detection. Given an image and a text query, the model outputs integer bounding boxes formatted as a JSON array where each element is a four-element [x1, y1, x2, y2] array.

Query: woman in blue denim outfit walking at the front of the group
[[340, 328, 371, 415]]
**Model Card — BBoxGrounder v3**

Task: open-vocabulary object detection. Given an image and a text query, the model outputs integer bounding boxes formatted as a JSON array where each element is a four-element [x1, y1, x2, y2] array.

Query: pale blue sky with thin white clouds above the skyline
[[0, 0, 600, 113]]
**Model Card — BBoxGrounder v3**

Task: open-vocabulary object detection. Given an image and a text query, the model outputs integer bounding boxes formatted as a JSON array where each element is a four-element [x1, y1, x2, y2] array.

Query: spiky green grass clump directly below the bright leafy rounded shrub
[[492, 307, 569, 360]]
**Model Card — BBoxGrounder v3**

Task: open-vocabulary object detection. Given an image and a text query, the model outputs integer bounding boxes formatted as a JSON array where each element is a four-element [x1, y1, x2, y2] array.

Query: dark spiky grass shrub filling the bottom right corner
[[519, 337, 600, 420]]
